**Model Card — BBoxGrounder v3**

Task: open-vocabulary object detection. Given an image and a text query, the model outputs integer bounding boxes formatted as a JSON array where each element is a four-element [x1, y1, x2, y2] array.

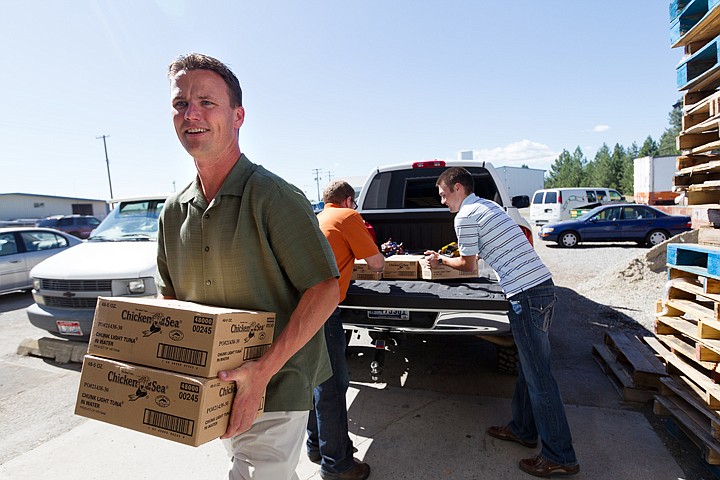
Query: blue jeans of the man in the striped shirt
[[508, 280, 577, 465]]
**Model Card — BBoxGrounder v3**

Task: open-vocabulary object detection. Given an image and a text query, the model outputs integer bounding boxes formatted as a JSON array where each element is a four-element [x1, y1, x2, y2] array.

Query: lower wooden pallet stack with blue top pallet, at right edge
[[645, 243, 720, 465]]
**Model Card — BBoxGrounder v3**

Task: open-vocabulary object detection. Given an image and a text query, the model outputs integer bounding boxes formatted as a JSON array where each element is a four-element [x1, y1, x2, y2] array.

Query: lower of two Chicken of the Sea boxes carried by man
[[75, 355, 265, 447]]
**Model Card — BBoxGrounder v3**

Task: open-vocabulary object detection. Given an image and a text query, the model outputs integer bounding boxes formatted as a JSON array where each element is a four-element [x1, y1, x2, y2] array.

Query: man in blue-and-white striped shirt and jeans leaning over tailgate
[[425, 167, 580, 477]]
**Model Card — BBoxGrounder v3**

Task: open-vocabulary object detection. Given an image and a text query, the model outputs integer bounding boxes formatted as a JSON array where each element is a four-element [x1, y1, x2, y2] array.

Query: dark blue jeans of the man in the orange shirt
[[307, 308, 354, 473]]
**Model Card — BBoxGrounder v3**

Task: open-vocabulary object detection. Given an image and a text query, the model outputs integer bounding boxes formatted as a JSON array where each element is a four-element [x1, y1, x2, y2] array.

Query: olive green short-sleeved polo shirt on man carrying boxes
[[158, 155, 339, 411]]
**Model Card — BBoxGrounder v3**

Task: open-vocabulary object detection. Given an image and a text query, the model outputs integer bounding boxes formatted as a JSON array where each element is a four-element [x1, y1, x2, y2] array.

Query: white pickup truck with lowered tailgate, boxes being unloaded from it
[[340, 160, 533, 373]]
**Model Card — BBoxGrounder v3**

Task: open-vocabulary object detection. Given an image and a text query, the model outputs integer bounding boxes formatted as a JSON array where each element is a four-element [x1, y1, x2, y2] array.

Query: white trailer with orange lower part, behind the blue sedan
[[633, 156, 678, 205]]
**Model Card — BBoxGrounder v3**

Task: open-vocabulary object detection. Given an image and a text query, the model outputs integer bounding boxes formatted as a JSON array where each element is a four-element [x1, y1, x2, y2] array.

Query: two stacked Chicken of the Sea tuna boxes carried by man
[[75, 297, 275, 446]]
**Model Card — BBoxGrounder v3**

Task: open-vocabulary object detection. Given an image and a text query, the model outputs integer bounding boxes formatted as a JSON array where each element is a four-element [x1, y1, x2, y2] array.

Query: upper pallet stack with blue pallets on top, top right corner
[[670, 0, 720, 210]]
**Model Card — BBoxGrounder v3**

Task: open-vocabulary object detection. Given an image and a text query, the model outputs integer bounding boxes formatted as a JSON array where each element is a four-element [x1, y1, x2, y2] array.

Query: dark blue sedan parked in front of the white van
[[538, 204, 692, 247]]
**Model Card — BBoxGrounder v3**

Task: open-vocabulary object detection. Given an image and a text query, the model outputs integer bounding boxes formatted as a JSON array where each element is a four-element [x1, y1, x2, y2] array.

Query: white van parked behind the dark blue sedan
[[530, 187, 625, 225]]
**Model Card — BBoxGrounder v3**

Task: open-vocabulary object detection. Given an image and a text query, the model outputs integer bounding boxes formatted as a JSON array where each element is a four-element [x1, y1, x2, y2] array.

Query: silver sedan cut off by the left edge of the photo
[[0, 227, 82, 293]]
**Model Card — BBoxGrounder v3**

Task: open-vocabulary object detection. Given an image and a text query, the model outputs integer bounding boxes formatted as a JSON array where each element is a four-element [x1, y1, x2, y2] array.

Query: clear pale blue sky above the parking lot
[[0, 0, 682, 200]]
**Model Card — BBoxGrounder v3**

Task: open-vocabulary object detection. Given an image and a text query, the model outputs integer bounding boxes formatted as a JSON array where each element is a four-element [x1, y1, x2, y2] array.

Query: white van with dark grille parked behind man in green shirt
[[27, 194, 167, 340]]
